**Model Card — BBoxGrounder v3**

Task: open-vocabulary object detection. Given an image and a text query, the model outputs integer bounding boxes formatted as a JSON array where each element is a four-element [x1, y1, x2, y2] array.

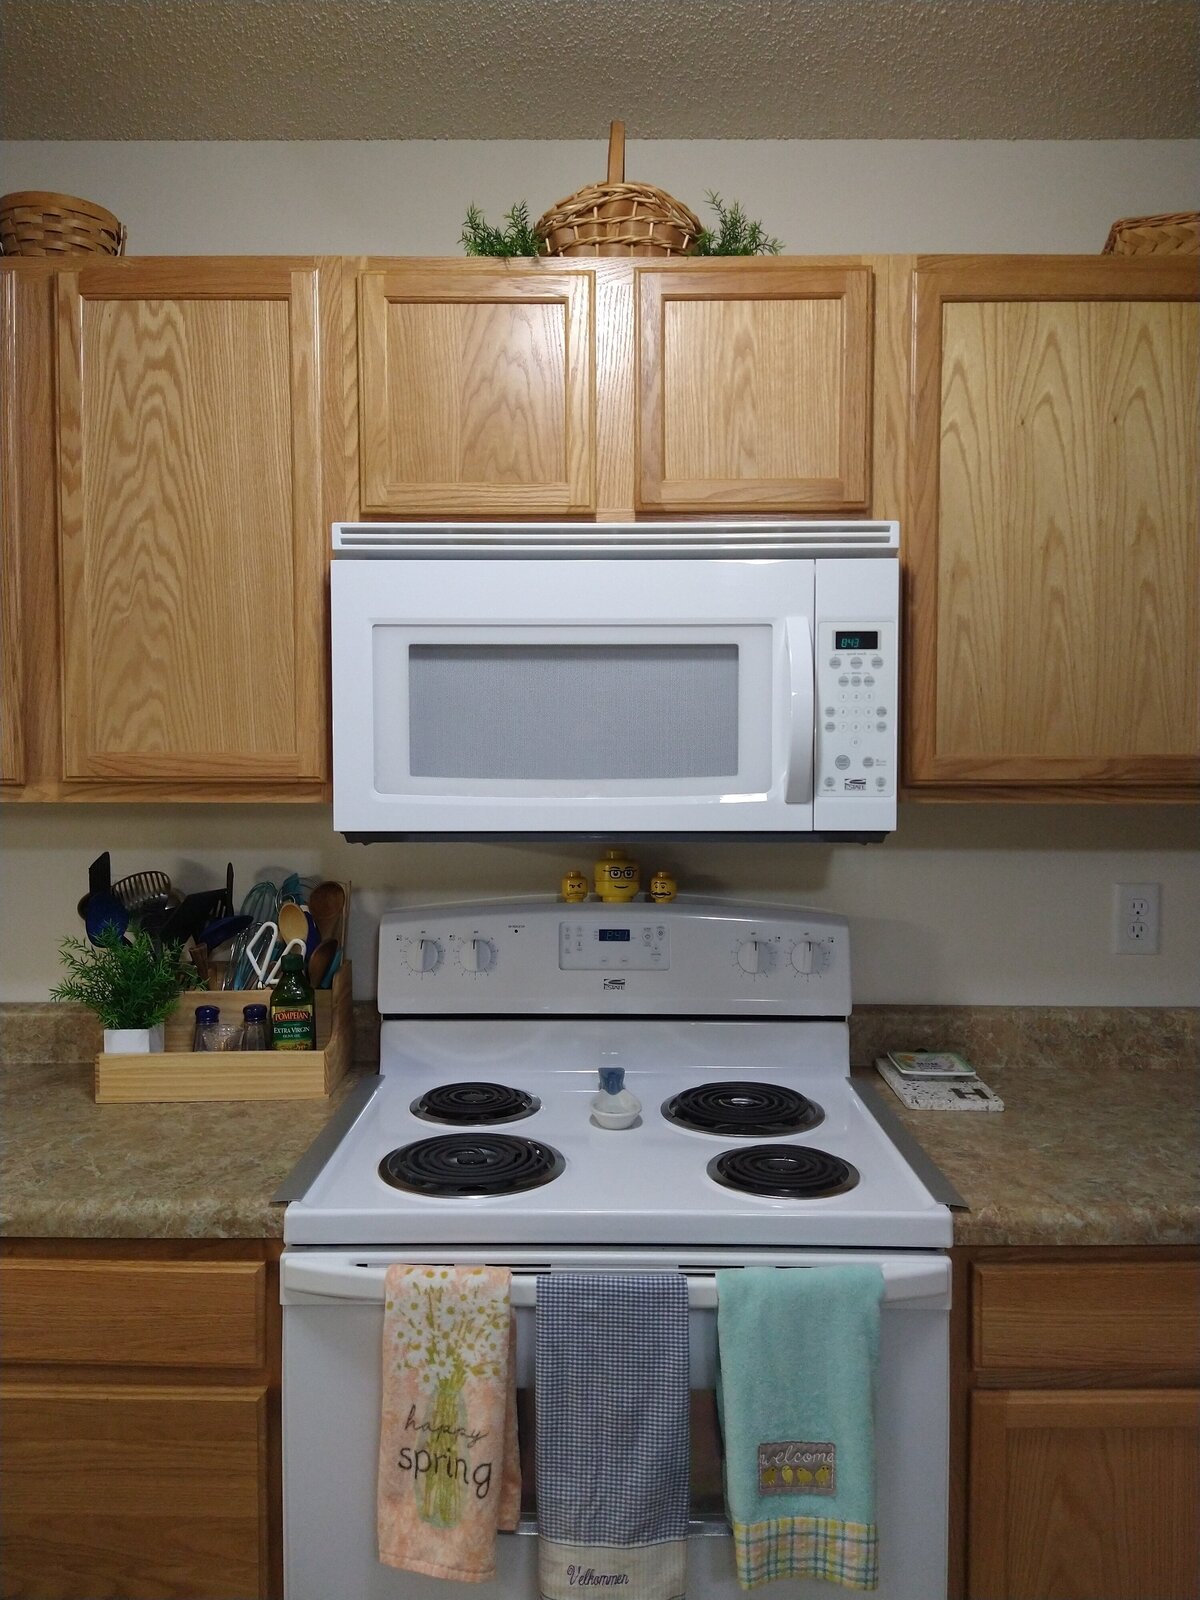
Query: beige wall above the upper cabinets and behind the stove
[[0, 141, 1200, 1005]]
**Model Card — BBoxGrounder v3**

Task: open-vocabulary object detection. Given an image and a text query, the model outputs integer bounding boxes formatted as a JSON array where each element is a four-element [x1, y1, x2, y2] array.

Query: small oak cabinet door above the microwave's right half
[[637, 264, 872, 512]]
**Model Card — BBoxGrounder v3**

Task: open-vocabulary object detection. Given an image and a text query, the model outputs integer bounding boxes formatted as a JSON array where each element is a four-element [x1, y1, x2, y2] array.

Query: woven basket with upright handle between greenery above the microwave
[[538, 122, 701, 256]]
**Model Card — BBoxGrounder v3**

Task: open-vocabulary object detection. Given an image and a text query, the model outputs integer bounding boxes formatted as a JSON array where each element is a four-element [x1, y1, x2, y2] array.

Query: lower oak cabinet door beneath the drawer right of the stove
[[968, 1389, 1200, 1600]]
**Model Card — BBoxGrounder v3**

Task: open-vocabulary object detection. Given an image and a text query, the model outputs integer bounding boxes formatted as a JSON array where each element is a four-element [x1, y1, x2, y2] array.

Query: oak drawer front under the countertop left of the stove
[[0, 1261, 267, 1370]]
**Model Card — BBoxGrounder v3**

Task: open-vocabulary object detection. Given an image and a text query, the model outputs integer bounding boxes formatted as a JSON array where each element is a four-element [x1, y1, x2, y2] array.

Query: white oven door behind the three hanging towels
[[280, 1250, 950, 1600]]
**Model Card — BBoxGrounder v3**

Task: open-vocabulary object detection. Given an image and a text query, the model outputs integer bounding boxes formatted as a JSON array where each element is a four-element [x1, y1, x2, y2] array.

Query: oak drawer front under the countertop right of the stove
[[973, 1261, 1200, 1373]]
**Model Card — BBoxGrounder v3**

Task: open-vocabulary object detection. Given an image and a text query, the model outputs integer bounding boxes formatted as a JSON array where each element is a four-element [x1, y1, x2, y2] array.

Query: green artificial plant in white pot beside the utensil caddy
[[50, 926, 203, 1054]]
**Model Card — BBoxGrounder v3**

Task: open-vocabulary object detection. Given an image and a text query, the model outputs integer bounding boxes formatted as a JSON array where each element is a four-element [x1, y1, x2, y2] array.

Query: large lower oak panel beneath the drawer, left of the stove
[[0, 1382, 267, 1600]]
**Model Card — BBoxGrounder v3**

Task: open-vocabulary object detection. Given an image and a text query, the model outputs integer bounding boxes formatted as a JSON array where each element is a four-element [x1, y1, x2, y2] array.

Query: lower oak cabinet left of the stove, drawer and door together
[[0, 1242, 282, 1600]]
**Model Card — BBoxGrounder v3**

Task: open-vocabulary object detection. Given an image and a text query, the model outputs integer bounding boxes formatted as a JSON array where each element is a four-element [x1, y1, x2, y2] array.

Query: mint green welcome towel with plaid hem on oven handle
[[717, 1266, 883, 1589]]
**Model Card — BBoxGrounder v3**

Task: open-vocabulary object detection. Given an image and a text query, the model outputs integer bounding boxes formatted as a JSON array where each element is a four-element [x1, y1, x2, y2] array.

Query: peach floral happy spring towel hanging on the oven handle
[[378, 1266, 520, 1584]]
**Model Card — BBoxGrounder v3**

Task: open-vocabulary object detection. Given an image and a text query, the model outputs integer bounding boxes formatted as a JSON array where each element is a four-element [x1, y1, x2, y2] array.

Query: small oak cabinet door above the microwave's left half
[[358, 262, 595, 517]]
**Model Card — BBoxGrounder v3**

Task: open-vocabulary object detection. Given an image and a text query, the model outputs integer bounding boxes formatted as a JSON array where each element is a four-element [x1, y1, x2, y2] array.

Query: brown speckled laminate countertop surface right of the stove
[[864, 1064, 1200, 1245]]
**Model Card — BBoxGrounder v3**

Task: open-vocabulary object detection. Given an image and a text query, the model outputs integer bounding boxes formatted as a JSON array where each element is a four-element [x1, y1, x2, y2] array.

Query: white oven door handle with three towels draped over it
[[280, 1256, 950, 1310]]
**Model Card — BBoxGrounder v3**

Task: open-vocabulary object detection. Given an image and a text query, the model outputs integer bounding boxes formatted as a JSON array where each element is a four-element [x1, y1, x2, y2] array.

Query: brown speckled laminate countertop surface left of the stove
[[0, 1062, 369, 1238]]
